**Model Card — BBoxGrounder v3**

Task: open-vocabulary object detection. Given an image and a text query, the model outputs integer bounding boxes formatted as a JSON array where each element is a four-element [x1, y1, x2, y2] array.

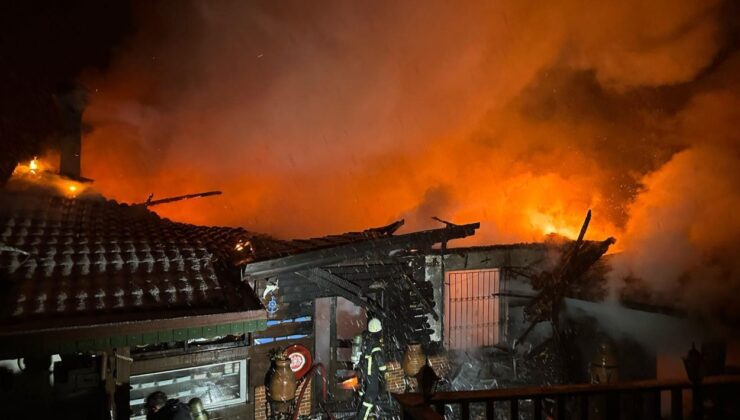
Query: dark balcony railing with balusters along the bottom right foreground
[[394, 375, 740, 420]]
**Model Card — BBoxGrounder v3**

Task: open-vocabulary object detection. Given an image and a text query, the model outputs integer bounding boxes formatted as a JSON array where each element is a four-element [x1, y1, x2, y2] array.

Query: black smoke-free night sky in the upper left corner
[[0, 0, 134, 180]]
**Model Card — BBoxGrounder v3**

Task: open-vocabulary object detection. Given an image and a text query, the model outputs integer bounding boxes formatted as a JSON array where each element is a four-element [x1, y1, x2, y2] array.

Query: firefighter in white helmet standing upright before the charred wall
[[357, 318, 385, 420]]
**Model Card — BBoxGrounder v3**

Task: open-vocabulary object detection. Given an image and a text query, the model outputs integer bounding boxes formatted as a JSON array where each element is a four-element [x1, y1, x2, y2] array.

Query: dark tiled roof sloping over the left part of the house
[[0, 190, 401, 327]]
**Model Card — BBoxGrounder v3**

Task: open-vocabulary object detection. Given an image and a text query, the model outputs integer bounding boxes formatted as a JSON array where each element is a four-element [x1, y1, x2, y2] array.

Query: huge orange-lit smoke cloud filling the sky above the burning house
[[78, 0, 740, 318]]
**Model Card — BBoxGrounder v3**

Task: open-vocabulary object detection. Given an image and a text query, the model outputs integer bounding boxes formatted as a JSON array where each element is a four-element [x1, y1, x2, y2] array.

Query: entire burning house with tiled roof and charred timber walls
[[0, 103, 736, 419]]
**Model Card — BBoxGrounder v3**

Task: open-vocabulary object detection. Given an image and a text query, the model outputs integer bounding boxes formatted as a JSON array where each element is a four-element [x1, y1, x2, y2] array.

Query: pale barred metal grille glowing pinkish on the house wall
[[444, 269, 500, 350]]
